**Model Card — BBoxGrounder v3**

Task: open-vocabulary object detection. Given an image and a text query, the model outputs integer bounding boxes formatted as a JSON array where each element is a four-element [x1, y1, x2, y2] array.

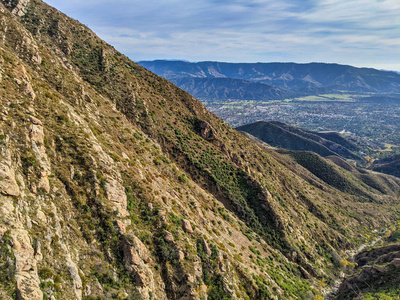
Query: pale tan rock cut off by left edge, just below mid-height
[[0, 150, 20, 196]]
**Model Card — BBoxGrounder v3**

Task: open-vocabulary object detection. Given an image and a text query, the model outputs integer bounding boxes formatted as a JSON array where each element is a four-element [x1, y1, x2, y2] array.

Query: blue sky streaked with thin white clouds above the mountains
[[45, 0, 400, 71]]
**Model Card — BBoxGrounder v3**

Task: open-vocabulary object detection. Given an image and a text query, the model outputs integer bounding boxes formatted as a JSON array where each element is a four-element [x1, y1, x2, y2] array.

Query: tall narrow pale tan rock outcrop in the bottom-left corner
[[11, 229, 43, 300]]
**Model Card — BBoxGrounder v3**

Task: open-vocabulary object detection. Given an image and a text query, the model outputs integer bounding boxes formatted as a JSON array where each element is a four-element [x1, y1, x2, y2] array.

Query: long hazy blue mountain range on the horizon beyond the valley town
[[139, 60, 400, 100]]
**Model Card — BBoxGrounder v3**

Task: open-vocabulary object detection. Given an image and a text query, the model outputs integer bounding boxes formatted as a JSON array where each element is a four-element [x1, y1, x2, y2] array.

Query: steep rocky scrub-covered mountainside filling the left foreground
[[0, 0, 400, 299]]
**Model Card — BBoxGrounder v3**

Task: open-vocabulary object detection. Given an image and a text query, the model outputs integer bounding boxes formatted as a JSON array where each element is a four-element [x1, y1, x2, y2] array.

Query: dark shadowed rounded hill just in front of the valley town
[[236, 121, 363, 160]]
